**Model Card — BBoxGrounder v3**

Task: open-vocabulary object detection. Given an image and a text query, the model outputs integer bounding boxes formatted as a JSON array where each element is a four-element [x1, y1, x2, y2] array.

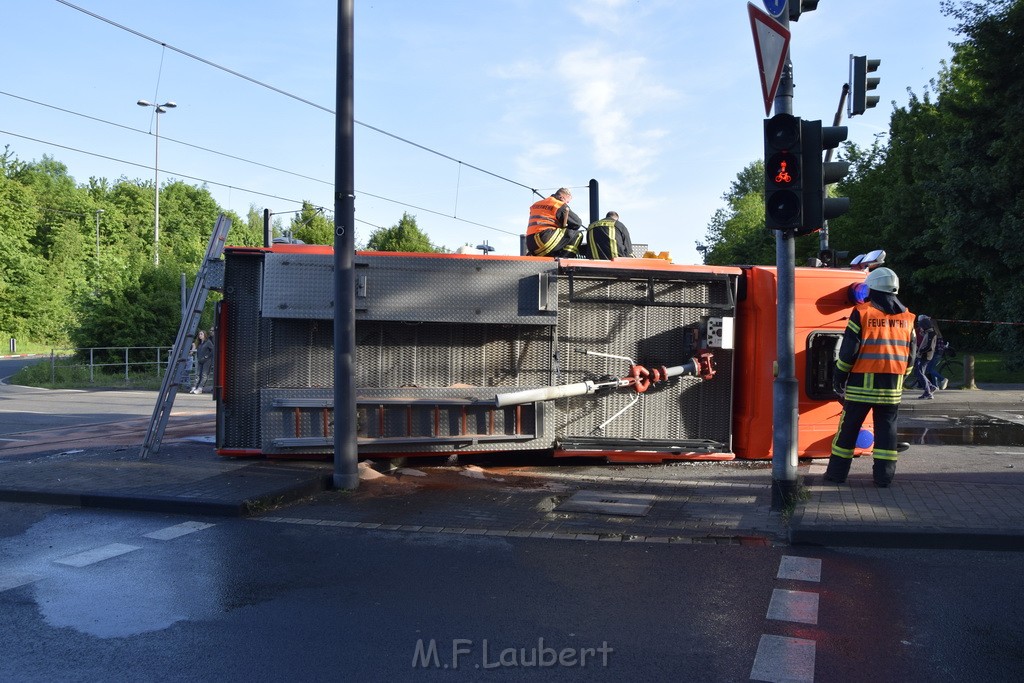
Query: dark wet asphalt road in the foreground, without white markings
[[0, 504, 1024, 681]]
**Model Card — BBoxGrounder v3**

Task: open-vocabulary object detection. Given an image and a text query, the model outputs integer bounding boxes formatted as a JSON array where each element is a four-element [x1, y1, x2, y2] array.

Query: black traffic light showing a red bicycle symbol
[[765, 114, 803, 230]]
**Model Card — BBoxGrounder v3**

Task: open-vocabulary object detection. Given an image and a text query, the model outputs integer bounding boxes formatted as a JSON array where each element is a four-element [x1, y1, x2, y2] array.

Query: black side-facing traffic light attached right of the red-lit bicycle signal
[[797, 121, 850, 236]]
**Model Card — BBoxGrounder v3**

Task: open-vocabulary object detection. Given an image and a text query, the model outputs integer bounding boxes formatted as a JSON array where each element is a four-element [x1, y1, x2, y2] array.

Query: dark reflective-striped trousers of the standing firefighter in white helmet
[[825, 400, 899, 486]]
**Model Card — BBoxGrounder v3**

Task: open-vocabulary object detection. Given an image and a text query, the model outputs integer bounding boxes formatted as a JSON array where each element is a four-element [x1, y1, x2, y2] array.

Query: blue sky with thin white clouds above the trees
[[0, 0, 957, 263]]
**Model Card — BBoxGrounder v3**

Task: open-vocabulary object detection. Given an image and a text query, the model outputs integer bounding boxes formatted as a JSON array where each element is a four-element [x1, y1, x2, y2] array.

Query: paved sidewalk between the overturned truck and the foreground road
[[0, 385, 1024, 549]]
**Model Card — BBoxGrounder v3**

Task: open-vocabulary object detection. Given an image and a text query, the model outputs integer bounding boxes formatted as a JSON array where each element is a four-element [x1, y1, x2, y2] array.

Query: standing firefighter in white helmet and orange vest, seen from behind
[[824, 268, 916, 487]]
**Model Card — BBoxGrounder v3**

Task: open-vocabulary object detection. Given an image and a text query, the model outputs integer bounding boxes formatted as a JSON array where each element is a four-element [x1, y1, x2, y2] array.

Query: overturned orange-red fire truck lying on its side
[[214, 245, 863, 462]]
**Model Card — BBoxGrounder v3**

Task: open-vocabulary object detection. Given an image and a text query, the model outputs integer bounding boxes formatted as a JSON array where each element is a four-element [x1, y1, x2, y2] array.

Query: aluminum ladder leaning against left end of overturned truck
[[139, 214, 231, 459]]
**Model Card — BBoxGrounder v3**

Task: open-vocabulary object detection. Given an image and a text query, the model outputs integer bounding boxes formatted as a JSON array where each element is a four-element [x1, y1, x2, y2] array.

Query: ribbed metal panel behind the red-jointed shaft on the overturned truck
[[552, 274, 732, 446]]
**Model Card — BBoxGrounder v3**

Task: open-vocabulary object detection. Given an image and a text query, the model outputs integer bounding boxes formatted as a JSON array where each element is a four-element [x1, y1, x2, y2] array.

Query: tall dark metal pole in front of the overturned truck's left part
[[334, 0, 359, 488]]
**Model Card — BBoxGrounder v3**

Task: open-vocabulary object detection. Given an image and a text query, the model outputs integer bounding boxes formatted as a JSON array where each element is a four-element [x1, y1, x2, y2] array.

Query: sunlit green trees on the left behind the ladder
[[0, 148, 315, 347]]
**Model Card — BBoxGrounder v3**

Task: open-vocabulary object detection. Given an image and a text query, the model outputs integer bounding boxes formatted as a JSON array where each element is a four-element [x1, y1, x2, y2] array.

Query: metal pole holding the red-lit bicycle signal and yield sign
[[771, 7, 800, 510]]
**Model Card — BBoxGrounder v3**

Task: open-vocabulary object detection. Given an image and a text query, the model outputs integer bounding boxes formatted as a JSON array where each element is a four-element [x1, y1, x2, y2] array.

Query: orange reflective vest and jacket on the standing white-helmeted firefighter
[[836, 303, 914, 404]]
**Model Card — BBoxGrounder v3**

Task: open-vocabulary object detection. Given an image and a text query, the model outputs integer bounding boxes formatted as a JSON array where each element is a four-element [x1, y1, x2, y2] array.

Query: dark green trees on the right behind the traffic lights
[[707, 0, 1024, 357]]
